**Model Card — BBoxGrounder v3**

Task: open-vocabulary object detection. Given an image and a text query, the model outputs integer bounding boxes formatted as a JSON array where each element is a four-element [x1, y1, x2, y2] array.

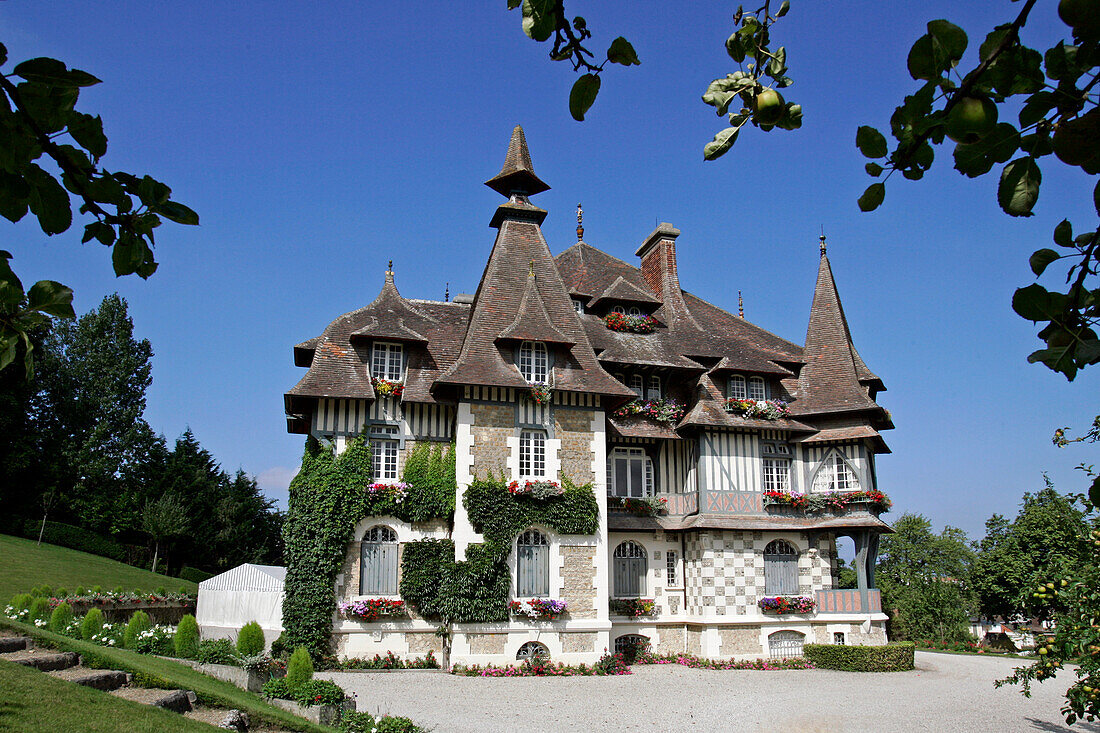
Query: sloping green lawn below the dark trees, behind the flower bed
[[0, 535, 198, 603]]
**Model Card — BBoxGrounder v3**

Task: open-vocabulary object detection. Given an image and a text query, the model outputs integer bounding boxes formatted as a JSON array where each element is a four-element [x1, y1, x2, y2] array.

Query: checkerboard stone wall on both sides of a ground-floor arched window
[[684, 530, 836, 616]]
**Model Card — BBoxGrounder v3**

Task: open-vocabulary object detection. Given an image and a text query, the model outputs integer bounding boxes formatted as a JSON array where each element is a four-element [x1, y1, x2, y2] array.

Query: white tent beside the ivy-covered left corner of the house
[[195, 564, 286, 646]]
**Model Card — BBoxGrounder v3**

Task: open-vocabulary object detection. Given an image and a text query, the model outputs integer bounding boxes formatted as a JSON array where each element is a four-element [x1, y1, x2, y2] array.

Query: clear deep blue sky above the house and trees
[[0, 0, 1100, 537]]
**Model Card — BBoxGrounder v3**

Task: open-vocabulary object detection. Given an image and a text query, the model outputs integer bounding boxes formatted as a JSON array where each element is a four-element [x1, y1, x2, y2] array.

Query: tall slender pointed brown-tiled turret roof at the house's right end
[[791, 236, 883, 415]]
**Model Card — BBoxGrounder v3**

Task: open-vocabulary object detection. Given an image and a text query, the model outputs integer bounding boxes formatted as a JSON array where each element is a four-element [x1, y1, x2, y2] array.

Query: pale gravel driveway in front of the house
[[318, 652, 1100, 733]]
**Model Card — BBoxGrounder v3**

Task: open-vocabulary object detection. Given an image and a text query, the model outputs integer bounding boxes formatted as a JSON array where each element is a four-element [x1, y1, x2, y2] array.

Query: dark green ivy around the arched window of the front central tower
[[400, 479, 600, 623]]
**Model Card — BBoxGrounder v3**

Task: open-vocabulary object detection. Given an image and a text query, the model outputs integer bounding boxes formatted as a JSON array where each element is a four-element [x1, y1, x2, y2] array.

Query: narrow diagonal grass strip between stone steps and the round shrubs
[[0, 617, 333, 733]]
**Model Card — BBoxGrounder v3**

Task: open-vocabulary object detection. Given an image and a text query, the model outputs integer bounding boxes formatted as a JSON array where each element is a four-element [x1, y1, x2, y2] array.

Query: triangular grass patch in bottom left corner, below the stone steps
[[0, 659, 215, 733]]
